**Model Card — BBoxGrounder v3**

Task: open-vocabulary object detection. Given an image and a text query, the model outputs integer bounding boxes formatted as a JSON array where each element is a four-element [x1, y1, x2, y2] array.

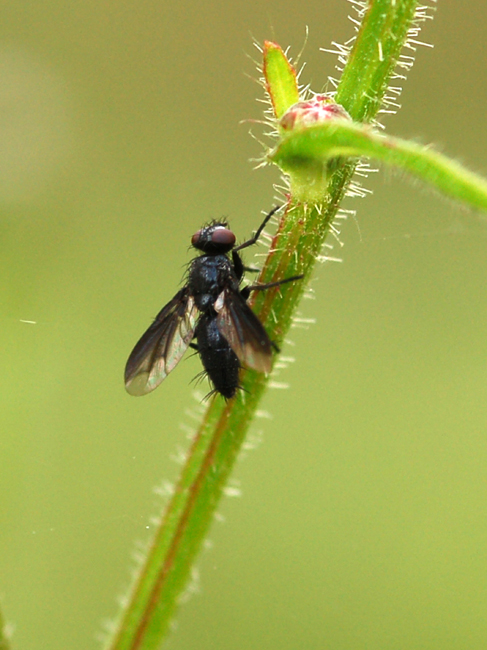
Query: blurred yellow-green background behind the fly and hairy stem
[[0, 0, 487, 650]]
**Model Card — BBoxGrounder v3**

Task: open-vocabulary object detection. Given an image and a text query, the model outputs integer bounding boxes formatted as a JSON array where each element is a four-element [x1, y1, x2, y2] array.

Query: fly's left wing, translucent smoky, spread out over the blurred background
[[125, 287, 199, 395]]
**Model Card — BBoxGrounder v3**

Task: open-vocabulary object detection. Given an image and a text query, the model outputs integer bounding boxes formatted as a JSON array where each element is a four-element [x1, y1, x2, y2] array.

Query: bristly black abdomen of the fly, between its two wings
[[196, 314, 240, 399]]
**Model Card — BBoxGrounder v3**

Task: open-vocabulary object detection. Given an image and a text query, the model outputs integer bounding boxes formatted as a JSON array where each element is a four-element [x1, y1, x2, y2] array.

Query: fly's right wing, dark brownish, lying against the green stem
[[214, 288, 272, 373]]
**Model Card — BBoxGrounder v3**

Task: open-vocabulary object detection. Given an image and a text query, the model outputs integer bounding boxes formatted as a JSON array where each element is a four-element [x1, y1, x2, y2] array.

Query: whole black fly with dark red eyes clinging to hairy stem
[[125, 207, 302, 399]]
